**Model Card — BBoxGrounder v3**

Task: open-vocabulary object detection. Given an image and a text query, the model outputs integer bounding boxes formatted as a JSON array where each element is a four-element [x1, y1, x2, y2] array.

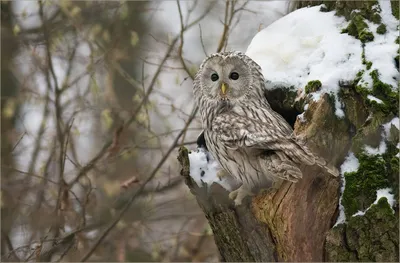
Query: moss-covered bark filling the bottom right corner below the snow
[[325, 197, 399, 262]]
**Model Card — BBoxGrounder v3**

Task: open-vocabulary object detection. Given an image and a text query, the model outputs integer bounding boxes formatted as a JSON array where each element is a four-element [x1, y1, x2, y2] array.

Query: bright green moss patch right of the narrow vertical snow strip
[[342, 153, 390, 218]]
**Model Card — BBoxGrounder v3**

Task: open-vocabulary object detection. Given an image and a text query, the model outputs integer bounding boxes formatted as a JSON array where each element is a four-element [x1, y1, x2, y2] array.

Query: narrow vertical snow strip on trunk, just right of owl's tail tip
[[334, 152, 360, 226]]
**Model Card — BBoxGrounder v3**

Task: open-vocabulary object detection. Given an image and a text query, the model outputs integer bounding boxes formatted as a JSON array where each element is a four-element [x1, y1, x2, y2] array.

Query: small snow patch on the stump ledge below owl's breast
[[189, 148, 236, 191]]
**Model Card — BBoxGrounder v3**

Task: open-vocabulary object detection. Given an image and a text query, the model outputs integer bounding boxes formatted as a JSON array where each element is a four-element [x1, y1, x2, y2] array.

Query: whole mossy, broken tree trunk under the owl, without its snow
[[178, 1, 399, 261]]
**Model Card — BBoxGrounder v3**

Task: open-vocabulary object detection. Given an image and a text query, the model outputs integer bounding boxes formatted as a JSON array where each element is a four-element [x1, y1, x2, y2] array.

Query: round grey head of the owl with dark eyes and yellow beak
[[194, 52, 263, 102]]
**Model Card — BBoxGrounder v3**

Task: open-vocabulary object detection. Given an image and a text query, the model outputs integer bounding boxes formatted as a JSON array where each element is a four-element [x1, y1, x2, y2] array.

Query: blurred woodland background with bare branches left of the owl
[[0, 0, 290, 262]]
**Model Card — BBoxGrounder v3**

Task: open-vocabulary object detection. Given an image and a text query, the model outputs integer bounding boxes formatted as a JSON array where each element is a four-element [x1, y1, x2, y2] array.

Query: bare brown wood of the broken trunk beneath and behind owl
[[179, 95, 350, 261]]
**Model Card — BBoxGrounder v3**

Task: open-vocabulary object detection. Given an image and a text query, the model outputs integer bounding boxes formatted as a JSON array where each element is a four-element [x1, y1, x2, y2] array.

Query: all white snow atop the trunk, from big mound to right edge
[[246, 0, 400, 118]]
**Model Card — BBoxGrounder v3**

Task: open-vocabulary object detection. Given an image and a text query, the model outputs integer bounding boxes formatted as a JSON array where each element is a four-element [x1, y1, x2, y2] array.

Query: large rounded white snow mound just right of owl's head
[[246, 6, 364, 118]]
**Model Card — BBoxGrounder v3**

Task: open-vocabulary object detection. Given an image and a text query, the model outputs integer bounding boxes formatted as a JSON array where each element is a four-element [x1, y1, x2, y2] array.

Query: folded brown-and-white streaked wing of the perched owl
[[212, 113, 315, 165]]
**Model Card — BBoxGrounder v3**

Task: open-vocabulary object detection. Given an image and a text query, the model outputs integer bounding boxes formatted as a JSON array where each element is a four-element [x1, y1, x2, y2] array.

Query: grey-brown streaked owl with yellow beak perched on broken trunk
[[193, 52, 338, 205]]
